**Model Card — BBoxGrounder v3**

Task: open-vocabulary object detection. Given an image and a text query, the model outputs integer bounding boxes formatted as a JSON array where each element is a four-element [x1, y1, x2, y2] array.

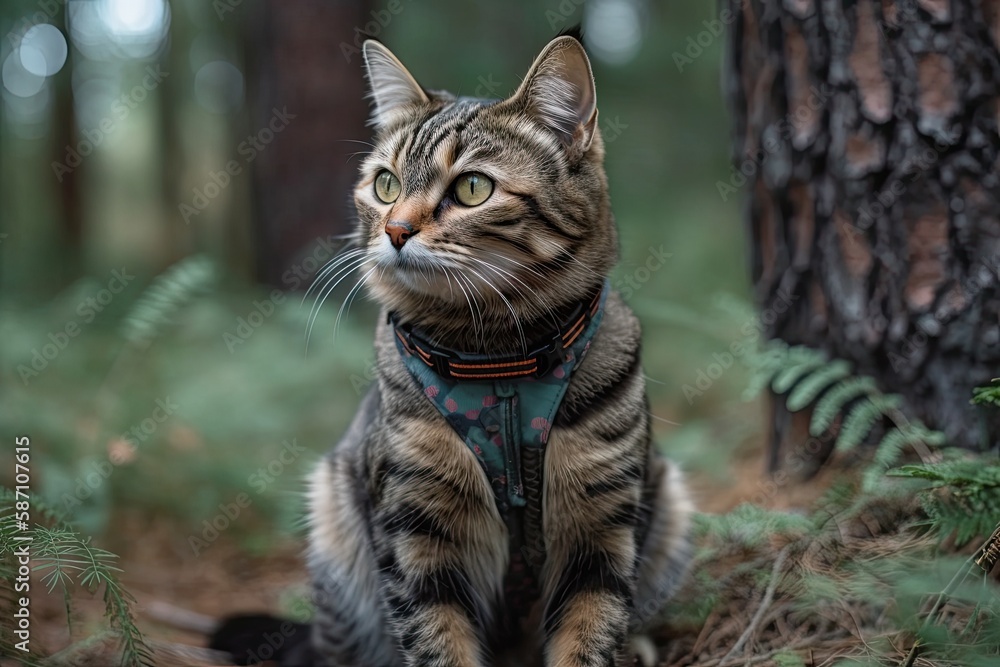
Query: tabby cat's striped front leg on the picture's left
[[376, 422, 506, 667]]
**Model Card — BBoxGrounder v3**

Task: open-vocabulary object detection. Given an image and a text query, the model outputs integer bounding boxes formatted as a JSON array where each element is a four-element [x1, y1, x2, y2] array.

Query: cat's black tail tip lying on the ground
[[209, 614, 319, 667]]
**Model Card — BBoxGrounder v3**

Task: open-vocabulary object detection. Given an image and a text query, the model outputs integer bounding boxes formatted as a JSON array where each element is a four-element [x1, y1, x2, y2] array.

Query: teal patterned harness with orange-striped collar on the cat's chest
[[392, 284, 608, 602]]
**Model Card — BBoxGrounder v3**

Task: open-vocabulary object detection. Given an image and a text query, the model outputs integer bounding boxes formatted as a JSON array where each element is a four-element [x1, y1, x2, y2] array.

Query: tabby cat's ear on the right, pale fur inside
[[514, 35, 597, 154]]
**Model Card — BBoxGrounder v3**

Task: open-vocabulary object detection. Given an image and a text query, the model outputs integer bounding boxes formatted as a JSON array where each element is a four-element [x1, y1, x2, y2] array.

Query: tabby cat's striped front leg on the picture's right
[[544, 436, 643, 667]]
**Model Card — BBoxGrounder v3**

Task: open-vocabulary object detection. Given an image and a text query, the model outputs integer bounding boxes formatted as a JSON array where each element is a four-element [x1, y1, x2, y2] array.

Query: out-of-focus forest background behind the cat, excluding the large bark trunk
[[0, 0, 763, 650]]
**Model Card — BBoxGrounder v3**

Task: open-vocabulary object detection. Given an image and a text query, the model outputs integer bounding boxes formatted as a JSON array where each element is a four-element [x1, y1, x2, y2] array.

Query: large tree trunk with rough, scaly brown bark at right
[[719, 0, 1000, 467]]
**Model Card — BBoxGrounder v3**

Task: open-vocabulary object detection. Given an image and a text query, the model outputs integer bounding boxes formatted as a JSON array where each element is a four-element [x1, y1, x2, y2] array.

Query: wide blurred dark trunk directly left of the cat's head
[[251, 0, 381, 289]]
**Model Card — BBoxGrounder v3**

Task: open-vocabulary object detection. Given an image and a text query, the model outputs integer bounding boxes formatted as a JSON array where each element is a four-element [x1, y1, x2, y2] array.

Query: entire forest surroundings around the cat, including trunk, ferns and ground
[[0, 0, 1000, 667]]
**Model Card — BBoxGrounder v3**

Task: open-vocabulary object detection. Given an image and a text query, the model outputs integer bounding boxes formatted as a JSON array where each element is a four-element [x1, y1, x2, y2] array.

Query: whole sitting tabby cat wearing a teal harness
[[214, 35, 692, 667]]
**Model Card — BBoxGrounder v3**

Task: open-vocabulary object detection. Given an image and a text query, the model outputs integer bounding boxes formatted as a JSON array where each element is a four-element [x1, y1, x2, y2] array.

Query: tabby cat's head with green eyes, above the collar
[[354, 36, 617, 352]]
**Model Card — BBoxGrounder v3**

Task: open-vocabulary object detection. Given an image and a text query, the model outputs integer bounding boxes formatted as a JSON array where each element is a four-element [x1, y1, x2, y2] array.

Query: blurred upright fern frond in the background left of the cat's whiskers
[[122, 255, 215, 346]]
